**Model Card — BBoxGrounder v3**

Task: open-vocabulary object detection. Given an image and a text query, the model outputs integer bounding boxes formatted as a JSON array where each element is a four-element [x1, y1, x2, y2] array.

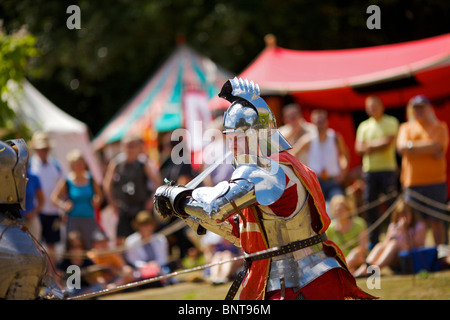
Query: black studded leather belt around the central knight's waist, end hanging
[[225, 233, 328, 300]]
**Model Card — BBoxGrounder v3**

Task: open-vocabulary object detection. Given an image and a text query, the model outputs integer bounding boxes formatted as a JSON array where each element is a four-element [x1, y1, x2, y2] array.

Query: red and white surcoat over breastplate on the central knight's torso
[[229, 152, 372, 300]]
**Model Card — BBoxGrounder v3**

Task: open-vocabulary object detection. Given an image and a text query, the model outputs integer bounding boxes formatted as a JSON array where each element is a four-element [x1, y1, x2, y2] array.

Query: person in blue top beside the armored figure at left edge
[[20, 167, 45, 241]]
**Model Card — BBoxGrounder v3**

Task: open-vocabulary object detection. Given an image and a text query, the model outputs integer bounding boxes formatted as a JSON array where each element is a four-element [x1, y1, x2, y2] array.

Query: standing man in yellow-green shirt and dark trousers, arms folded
[[355, 96, 399, 248]]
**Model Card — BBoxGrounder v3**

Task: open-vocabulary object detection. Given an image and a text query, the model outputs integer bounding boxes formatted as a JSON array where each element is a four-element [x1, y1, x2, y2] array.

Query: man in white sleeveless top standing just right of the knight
[[291, 109, 350, 202]]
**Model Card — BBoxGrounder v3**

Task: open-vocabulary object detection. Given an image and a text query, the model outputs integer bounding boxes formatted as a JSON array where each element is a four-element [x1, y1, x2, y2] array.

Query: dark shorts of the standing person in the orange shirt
[[405, 182, 448, 221]]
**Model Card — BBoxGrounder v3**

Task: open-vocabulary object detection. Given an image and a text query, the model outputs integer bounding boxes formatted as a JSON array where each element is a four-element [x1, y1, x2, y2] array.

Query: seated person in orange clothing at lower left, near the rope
[[87, 230, 134, 288]]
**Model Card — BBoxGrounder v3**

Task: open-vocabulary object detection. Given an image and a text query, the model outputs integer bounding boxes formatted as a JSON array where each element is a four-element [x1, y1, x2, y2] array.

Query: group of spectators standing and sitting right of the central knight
[[291, 95, 449, 277]]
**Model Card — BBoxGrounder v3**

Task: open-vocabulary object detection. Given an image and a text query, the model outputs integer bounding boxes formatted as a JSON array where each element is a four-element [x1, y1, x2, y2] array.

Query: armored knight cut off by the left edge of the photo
[[0, 139, 47, 300]]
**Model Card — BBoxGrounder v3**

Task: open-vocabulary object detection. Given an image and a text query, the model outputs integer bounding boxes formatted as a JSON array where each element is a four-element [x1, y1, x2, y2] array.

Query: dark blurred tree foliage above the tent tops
[[0, 0, 450, 133]]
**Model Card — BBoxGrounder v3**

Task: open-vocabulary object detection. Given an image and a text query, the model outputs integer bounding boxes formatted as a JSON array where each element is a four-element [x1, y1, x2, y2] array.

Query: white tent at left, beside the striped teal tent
[[12, 80, 103, 183]]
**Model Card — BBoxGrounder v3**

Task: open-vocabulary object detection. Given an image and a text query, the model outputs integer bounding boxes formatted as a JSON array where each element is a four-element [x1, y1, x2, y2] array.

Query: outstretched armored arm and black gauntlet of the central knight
[[155, 159, 286, 245]]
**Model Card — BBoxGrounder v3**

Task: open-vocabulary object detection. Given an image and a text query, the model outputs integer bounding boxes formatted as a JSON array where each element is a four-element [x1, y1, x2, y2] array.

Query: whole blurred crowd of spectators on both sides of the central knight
[[22, 95, 449, 294]]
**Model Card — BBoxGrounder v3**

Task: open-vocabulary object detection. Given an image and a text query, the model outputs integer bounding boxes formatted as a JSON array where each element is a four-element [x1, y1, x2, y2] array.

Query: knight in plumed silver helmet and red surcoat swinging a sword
[[155, 78, 374, 300]]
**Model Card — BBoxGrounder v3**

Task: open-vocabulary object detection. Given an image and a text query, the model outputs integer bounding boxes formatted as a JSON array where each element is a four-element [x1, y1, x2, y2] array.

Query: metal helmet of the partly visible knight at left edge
[[0, 139, 28, 209]]
